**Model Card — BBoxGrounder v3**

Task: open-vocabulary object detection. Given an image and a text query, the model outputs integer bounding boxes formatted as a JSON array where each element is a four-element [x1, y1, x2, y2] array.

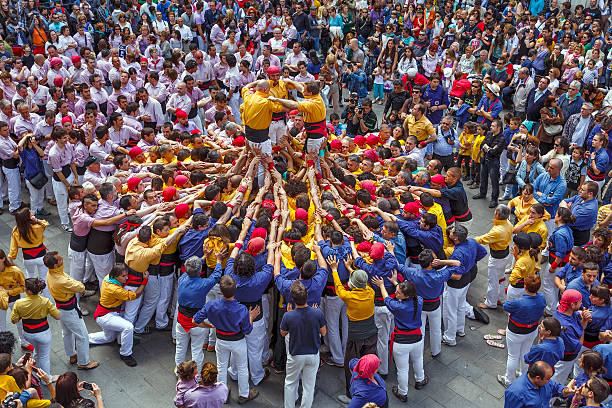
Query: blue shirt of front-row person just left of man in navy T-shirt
[[193, 298, 253, 335]]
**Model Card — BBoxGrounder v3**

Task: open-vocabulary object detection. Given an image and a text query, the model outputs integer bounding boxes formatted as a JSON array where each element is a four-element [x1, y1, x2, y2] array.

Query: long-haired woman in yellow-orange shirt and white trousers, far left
[[8, 208, 49, 296]]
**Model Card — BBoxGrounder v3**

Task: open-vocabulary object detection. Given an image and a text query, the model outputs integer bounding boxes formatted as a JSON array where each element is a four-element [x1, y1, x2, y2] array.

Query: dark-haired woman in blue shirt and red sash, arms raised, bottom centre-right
[[372, 274, 428, 402]]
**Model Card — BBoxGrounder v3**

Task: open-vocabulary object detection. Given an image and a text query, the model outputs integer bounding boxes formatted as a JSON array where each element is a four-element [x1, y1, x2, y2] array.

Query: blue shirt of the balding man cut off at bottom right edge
[[504, 373, 564, 408]]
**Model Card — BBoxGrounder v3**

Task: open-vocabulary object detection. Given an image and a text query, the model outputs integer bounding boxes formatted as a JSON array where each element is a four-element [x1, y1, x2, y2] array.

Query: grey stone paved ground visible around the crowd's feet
[[0, 106, 507, 408]]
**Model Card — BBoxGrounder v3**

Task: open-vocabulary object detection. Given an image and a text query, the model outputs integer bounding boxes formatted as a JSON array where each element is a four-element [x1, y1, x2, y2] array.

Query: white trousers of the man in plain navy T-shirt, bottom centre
[[285, 353, 320, 408]]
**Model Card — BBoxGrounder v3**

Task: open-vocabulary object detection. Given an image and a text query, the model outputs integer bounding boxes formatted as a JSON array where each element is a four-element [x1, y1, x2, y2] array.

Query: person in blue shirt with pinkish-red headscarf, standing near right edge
[[551, 289, 591, 384]]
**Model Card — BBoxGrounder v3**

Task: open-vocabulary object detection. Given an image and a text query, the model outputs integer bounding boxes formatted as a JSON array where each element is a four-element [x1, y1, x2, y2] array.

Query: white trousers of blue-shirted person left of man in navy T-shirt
[[215, 339, 249, 398]]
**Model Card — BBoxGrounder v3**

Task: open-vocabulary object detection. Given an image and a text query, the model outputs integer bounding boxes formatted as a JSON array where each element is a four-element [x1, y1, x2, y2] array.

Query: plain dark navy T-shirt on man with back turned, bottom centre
[[280, 306, 326, 356]]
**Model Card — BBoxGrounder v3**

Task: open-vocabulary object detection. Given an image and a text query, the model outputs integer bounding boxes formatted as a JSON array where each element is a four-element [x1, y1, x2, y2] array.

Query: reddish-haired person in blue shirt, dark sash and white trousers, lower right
[[497, 274, 546, 387]]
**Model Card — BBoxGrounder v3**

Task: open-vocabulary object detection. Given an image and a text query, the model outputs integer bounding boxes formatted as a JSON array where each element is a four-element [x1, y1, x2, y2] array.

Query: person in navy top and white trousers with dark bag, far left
[[17, 133, 46, 217]]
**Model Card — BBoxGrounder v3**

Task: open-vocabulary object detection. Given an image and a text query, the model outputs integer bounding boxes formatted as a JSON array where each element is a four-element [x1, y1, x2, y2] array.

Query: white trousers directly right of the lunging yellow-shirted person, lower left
[[134, 275, 174, 333]]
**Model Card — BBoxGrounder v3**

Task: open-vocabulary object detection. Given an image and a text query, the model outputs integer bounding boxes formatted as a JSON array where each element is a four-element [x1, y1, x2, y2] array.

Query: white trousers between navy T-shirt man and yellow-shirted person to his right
[[324, 296, 348, 364]]
